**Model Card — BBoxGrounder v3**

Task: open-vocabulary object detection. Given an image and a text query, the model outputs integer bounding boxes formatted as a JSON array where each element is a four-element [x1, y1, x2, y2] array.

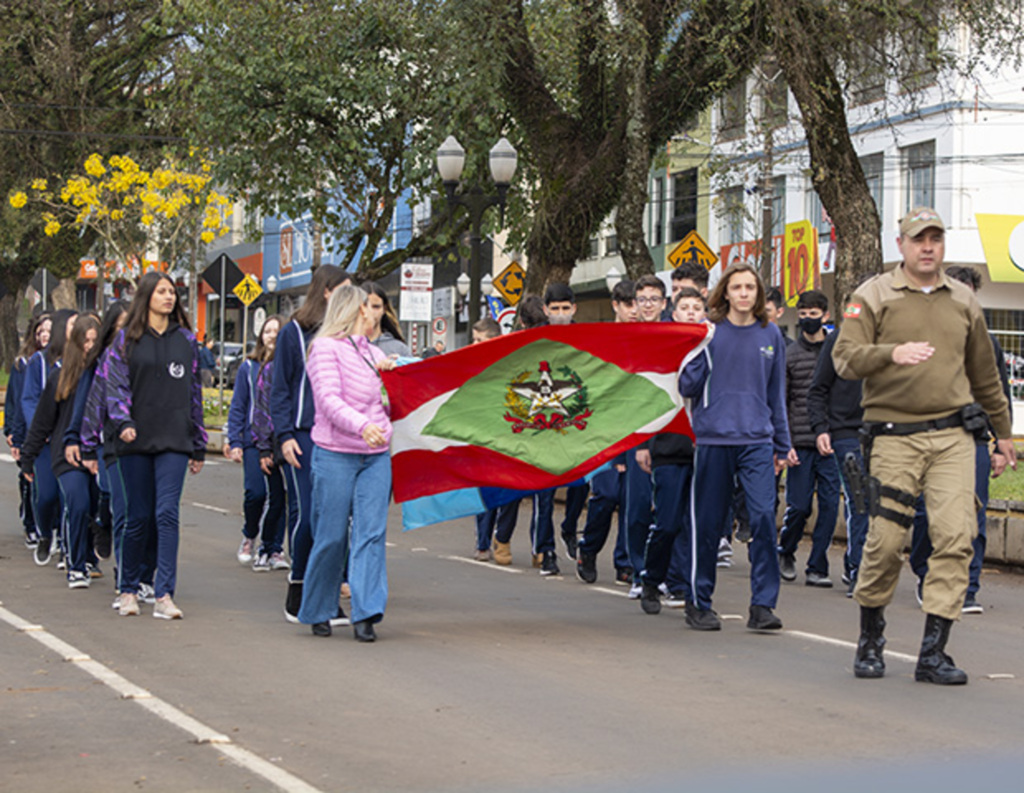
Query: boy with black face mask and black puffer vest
[[778, 290, 840, 588]]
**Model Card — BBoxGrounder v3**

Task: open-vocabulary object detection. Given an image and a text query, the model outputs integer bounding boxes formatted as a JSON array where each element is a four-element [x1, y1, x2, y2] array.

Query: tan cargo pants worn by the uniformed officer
[[853, 427, 978, 620]]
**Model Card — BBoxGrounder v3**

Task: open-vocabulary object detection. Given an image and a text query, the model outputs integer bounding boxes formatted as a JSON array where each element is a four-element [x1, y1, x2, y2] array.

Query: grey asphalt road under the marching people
[[0, 458, 1024, 792]]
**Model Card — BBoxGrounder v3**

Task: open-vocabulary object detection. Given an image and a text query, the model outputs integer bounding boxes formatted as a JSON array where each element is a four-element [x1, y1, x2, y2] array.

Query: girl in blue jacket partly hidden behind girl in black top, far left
[[22, 308, 78, 566]]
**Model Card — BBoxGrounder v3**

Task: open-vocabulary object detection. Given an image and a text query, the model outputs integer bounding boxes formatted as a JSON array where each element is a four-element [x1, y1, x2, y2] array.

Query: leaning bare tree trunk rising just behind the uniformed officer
[[771, 0, 883, 319]]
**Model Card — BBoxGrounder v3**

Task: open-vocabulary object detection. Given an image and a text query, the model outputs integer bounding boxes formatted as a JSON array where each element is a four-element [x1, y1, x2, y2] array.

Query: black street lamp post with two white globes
[[437, 135, 517, 327]]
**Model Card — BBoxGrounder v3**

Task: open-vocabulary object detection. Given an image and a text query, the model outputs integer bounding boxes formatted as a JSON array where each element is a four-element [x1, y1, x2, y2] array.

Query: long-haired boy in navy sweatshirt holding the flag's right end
[[679, 263, 797, 630]]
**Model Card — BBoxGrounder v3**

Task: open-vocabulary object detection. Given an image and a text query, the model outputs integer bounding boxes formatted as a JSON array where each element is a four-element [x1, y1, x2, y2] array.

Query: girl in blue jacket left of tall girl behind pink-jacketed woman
[[223, 315, 291, 573]]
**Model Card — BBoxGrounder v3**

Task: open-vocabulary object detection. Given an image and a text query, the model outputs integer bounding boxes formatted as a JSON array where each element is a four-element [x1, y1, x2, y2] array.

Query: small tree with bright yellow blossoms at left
[[9, 151, 231, 281]]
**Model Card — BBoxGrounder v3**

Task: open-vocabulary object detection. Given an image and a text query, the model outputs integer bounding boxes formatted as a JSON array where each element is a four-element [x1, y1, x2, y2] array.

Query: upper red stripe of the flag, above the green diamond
[[383, 323, 709, 421]]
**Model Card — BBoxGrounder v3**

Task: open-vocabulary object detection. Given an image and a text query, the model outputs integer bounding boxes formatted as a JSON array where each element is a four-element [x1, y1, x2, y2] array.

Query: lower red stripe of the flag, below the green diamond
[[391, 411, 693, 503]]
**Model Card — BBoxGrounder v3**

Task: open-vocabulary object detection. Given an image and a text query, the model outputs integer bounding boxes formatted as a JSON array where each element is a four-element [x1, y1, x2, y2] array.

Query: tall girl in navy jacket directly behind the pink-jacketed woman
[[270, 264, 350, 624]]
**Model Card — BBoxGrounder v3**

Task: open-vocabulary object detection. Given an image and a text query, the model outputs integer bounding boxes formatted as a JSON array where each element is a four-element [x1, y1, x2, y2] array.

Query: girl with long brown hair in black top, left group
[[20, 314, 99, 589]]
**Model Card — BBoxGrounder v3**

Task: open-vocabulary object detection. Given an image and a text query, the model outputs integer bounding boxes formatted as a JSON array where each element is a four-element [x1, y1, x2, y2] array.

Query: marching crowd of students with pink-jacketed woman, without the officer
[[4, 204, 1009, 680]]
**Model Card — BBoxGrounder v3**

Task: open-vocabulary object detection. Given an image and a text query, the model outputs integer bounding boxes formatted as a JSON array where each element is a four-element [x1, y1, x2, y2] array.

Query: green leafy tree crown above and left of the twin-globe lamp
[[177, 0, 512, 274]]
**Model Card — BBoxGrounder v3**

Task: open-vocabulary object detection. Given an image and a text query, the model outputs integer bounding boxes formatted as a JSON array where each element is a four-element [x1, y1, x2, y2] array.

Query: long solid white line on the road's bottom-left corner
[[0, 603, 322, 793]]
